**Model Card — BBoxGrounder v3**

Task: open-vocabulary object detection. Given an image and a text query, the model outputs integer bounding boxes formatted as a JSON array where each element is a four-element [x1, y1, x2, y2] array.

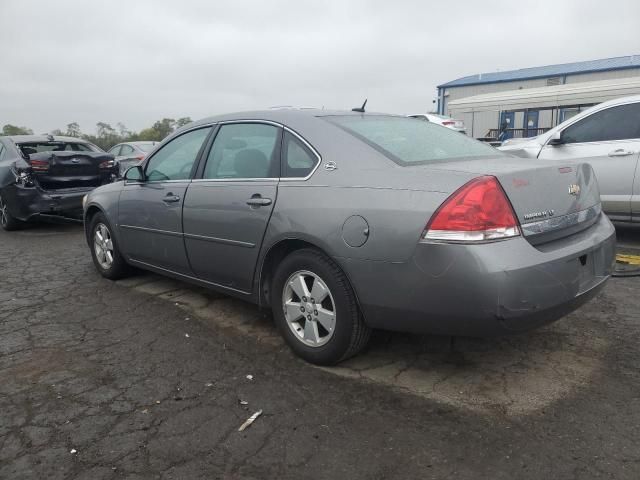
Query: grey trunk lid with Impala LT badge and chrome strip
[[420, 157, 600, 244]]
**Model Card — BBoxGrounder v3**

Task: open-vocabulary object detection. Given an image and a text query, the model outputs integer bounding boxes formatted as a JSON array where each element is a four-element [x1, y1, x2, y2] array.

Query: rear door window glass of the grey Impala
[[202, 123, 280, 179]]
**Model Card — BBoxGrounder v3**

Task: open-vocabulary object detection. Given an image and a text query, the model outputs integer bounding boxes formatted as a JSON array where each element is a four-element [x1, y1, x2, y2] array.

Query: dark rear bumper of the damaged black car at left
[[3, 184, 95, 221]]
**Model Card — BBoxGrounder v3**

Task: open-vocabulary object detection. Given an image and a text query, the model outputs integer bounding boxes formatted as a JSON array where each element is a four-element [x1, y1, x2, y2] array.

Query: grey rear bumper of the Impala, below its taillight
[[337, 215, 615, 336]]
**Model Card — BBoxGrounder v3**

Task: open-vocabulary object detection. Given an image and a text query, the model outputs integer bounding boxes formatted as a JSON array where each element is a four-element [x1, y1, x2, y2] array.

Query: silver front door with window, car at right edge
[[539, 103, 640, 221]]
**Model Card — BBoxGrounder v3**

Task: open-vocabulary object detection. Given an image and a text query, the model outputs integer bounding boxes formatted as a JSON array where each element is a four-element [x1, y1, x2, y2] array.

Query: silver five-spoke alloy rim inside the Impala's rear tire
[[282, 270, 336, 347]]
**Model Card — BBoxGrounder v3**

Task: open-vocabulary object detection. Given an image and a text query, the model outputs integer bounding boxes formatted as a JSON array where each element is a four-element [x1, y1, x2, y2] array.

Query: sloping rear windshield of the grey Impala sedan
[[323, 115, 505, 166]]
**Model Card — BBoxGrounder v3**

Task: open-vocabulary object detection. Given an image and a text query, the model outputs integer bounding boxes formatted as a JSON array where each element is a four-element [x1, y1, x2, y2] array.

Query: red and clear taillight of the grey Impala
[[422, 176, 520, 242]]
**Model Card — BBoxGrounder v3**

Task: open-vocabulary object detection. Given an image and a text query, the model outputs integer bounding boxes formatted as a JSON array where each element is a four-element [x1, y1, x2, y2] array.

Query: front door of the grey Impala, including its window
[[118, 127, 211, 274]]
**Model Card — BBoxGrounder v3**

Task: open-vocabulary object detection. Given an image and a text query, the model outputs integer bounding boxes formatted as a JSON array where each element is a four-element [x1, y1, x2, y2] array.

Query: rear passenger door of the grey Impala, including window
[[183, 122, 282, 292]]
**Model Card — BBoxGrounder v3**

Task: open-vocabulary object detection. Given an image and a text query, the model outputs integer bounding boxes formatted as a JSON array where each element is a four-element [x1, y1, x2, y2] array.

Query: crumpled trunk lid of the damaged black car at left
[[28, 151, 117, 190]]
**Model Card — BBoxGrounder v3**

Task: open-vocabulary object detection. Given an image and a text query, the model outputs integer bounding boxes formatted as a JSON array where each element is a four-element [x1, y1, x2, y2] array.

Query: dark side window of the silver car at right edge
[[562, 103, 640, 143]]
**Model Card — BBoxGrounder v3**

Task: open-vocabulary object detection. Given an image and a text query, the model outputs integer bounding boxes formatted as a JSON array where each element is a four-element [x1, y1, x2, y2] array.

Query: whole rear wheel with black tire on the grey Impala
[[270, 249, 371, 365]]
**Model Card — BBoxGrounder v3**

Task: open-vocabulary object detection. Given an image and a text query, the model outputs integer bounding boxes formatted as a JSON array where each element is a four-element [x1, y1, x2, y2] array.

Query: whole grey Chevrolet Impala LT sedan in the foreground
[[84, 110, 615, 365]]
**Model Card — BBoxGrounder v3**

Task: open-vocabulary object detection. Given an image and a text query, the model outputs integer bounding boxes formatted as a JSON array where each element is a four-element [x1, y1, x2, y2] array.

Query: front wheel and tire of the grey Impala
[[89, 213, 130, 280]]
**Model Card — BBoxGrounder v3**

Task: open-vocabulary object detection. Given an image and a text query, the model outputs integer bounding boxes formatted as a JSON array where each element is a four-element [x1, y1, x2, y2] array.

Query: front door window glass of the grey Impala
[[145, 127, 211, 181]]
